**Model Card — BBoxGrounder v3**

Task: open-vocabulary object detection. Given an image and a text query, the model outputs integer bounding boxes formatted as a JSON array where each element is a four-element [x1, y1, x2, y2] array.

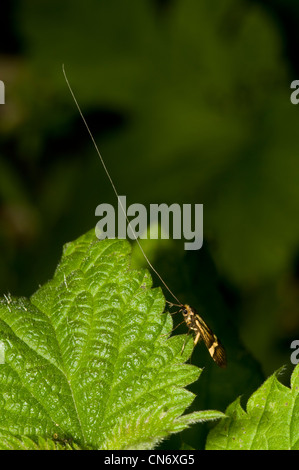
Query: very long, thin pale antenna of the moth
[[62, 64, 182, 306]]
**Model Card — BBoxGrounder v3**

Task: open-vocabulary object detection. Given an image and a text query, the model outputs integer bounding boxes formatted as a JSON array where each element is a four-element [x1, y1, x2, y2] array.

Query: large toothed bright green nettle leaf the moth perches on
[[0, 231, 223, 449]]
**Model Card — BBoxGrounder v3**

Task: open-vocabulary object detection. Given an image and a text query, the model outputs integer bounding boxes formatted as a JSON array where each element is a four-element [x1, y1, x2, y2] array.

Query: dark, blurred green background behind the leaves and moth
[[0, 0, 299, 448]]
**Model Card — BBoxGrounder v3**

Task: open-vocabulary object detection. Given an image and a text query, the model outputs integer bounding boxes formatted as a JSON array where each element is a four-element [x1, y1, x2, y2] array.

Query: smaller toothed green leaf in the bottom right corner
[[207, 365, 299, 450]]
